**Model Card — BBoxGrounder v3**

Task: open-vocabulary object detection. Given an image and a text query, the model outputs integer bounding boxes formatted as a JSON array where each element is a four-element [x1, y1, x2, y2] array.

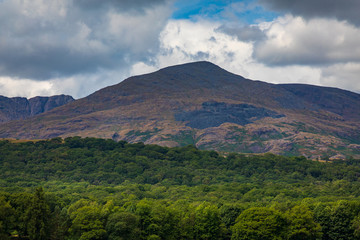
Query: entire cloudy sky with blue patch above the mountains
[[0, 0, 360, 98]]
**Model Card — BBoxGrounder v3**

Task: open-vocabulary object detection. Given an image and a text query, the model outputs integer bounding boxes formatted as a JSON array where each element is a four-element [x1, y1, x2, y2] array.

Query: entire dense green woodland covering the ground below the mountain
[[0, 137, 360, 240]]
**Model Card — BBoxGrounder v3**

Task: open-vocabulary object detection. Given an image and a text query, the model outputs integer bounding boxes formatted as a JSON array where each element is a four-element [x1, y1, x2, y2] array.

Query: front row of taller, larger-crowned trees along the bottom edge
[[0, 187, 360, 240]]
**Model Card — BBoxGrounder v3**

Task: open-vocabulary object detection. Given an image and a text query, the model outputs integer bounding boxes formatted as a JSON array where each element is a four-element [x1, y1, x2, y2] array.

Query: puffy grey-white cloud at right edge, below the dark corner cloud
[[254, 15, 360, 66]]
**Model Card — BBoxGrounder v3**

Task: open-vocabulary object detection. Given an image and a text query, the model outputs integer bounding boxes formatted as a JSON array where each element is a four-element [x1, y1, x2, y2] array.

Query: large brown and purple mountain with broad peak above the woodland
[[0, 62, 360, 158]]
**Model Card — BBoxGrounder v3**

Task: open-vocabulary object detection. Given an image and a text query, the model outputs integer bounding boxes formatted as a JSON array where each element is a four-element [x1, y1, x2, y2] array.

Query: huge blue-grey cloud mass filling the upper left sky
[[0, 0, 171, 80]]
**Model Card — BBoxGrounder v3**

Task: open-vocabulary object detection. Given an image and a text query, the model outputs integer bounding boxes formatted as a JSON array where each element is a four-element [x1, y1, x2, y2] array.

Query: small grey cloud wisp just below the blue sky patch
[[217, 25, 266, 42]]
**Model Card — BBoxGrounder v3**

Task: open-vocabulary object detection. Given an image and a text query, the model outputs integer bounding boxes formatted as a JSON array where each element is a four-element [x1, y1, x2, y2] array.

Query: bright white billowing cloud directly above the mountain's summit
[[133, 20, 252, 74]]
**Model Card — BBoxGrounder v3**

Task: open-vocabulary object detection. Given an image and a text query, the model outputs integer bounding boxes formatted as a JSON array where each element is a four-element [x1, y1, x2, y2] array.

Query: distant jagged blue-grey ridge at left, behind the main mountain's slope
[[0, 95, 74, 123]]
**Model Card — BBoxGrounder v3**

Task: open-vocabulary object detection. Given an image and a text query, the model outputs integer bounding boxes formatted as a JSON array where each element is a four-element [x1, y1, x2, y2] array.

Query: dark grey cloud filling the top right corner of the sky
[[260, 0, 360, 26]]
